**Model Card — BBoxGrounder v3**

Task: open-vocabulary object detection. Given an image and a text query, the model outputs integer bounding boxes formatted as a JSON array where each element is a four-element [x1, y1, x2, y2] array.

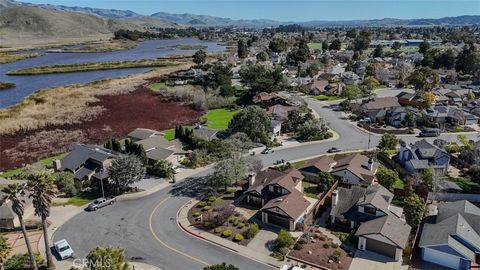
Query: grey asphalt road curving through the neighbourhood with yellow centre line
[[54, 100, 477, 270]]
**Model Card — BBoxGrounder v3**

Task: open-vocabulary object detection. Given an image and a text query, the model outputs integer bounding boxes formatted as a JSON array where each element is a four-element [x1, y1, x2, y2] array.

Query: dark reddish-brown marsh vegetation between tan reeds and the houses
[[0, 85, 202, 170]]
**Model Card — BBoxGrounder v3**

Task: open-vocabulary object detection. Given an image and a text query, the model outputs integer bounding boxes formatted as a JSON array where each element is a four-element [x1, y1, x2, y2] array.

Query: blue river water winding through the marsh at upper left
[[0, 38, 225, 108]]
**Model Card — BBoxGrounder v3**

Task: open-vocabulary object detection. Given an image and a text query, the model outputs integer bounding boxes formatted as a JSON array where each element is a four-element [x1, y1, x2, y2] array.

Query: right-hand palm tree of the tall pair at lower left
[[28, 172, 57, 269]]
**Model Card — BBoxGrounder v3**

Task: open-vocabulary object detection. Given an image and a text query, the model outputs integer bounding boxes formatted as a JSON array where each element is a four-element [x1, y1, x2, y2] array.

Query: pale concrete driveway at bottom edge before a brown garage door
[[348, 250, 408, 270]]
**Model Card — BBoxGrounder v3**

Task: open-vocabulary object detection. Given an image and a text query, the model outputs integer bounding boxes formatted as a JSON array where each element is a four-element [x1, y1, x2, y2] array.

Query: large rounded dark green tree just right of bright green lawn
[[228, 106, 270, 143]]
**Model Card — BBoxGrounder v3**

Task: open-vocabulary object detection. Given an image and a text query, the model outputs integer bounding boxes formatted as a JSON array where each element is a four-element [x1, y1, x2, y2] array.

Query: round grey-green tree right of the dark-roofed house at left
[[108, 155, 145, 193]]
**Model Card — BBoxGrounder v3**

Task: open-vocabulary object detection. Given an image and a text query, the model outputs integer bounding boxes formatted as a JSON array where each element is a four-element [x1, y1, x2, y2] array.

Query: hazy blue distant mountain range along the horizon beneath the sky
[[0, 0, 480, 34]]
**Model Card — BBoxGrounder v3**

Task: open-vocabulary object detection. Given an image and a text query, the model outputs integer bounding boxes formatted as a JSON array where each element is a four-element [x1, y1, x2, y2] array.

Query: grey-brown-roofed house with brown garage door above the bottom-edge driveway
[[330, 185, 411, 261]]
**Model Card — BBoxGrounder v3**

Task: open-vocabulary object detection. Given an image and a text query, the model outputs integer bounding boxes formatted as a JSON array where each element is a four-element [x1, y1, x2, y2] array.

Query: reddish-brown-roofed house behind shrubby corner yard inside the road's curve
[[245, 168, 313, 231]]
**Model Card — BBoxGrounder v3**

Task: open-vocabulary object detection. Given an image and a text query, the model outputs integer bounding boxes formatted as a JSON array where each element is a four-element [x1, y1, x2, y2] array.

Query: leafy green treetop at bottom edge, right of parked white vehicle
[[87, 247, 131, 270]]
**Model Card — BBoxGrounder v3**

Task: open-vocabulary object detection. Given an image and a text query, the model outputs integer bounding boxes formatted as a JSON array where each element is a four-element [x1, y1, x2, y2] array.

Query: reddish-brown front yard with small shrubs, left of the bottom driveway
[[288, 229, 353, 269]]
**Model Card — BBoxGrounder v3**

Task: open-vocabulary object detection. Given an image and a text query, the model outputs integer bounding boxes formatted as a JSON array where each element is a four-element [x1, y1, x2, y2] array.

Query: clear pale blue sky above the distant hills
[[21, 0, 480, 21]]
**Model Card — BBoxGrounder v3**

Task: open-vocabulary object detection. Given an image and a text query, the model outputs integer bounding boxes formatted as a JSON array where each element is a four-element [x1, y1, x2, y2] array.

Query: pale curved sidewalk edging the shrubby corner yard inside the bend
[[177, 199, 284, 267]]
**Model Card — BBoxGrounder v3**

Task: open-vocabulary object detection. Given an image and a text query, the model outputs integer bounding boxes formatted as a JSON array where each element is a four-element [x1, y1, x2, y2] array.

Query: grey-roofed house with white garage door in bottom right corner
[[419, 200, 480, 270]]
